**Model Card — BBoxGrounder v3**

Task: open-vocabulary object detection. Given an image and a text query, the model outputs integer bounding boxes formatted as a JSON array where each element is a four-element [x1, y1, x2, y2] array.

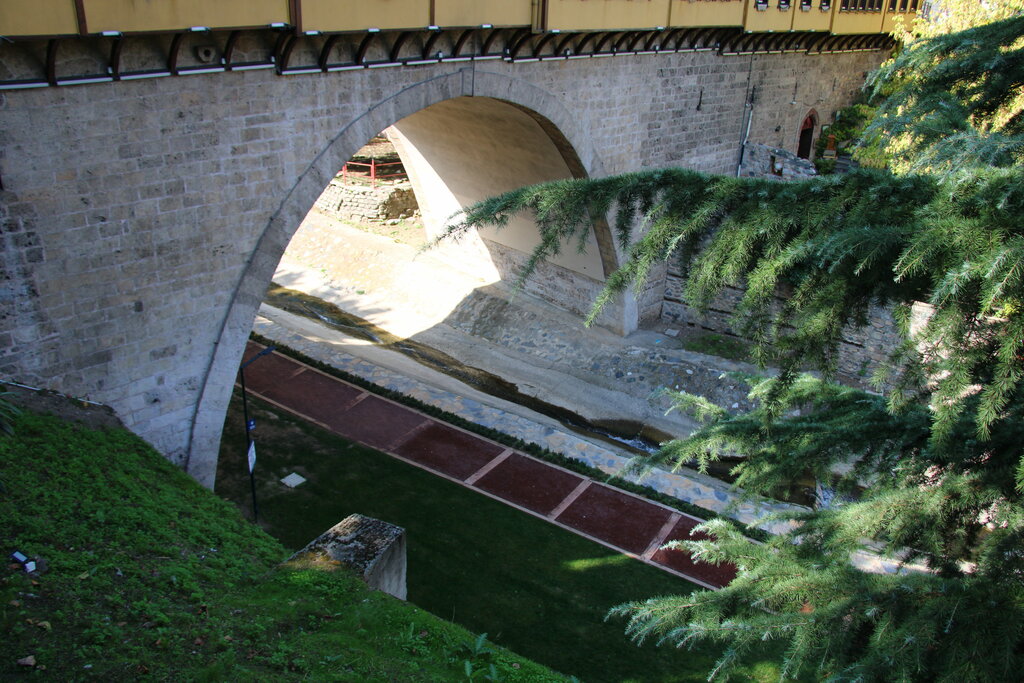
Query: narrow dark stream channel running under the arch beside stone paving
[[264, 283, 808, 505]]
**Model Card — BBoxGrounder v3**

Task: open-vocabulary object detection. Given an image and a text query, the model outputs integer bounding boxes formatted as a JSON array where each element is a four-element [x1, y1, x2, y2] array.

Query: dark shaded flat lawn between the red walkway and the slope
[[217, 389, 778, 682]]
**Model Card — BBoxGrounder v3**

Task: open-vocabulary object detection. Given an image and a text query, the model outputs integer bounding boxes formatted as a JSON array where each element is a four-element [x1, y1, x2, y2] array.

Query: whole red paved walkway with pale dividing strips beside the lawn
[[239, 342, 736, 588]]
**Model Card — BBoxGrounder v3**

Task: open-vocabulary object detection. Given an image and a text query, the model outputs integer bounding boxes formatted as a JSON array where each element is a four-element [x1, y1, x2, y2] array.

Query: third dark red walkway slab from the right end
[[475, 454, 583, 516]]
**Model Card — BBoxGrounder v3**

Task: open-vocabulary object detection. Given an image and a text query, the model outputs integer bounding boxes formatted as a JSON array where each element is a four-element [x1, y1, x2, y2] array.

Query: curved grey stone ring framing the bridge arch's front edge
[[185, 70, 618, 487]]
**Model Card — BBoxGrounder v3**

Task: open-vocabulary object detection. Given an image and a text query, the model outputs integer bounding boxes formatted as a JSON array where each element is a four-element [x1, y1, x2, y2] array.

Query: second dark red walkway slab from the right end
[[555, 484, 672, 555]]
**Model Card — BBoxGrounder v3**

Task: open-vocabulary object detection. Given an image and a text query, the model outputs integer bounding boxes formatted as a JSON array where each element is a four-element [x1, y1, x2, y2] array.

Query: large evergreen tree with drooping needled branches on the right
[[451, 14, 1024, 681]]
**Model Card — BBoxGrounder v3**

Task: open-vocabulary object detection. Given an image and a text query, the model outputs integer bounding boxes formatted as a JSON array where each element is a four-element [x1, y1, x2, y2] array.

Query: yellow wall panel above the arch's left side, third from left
[[302, 0, 430, 31]]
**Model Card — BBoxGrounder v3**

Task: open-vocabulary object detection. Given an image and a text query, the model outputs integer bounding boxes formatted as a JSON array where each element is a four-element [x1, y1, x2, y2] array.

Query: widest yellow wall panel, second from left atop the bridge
[[84, 0, 291, 33]]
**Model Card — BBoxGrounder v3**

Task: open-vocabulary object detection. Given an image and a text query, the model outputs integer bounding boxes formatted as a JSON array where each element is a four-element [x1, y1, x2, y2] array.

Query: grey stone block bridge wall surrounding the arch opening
[[0, 52, 883, 485]]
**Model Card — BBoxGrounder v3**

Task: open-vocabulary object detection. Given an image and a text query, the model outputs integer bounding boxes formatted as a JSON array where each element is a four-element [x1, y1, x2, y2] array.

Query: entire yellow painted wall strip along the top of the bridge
[[0, 0, 897, 36]]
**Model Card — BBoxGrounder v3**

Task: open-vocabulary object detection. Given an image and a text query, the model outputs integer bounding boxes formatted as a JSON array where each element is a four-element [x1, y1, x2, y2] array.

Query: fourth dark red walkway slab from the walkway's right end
[[394, 422, 505, 481]]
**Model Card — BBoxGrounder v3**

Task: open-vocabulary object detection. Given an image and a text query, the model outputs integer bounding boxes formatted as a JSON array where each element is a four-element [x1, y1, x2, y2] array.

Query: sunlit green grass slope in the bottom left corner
[[0, 403, 564, 681]]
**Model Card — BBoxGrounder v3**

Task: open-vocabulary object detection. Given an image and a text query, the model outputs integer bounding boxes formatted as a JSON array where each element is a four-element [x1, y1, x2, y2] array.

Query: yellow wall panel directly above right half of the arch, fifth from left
[[546, 0, 670, 31]]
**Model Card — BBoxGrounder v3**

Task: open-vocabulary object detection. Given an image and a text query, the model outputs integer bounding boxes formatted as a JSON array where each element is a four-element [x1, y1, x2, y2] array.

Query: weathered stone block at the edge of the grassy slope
[[288, 514, 407, 600]]
